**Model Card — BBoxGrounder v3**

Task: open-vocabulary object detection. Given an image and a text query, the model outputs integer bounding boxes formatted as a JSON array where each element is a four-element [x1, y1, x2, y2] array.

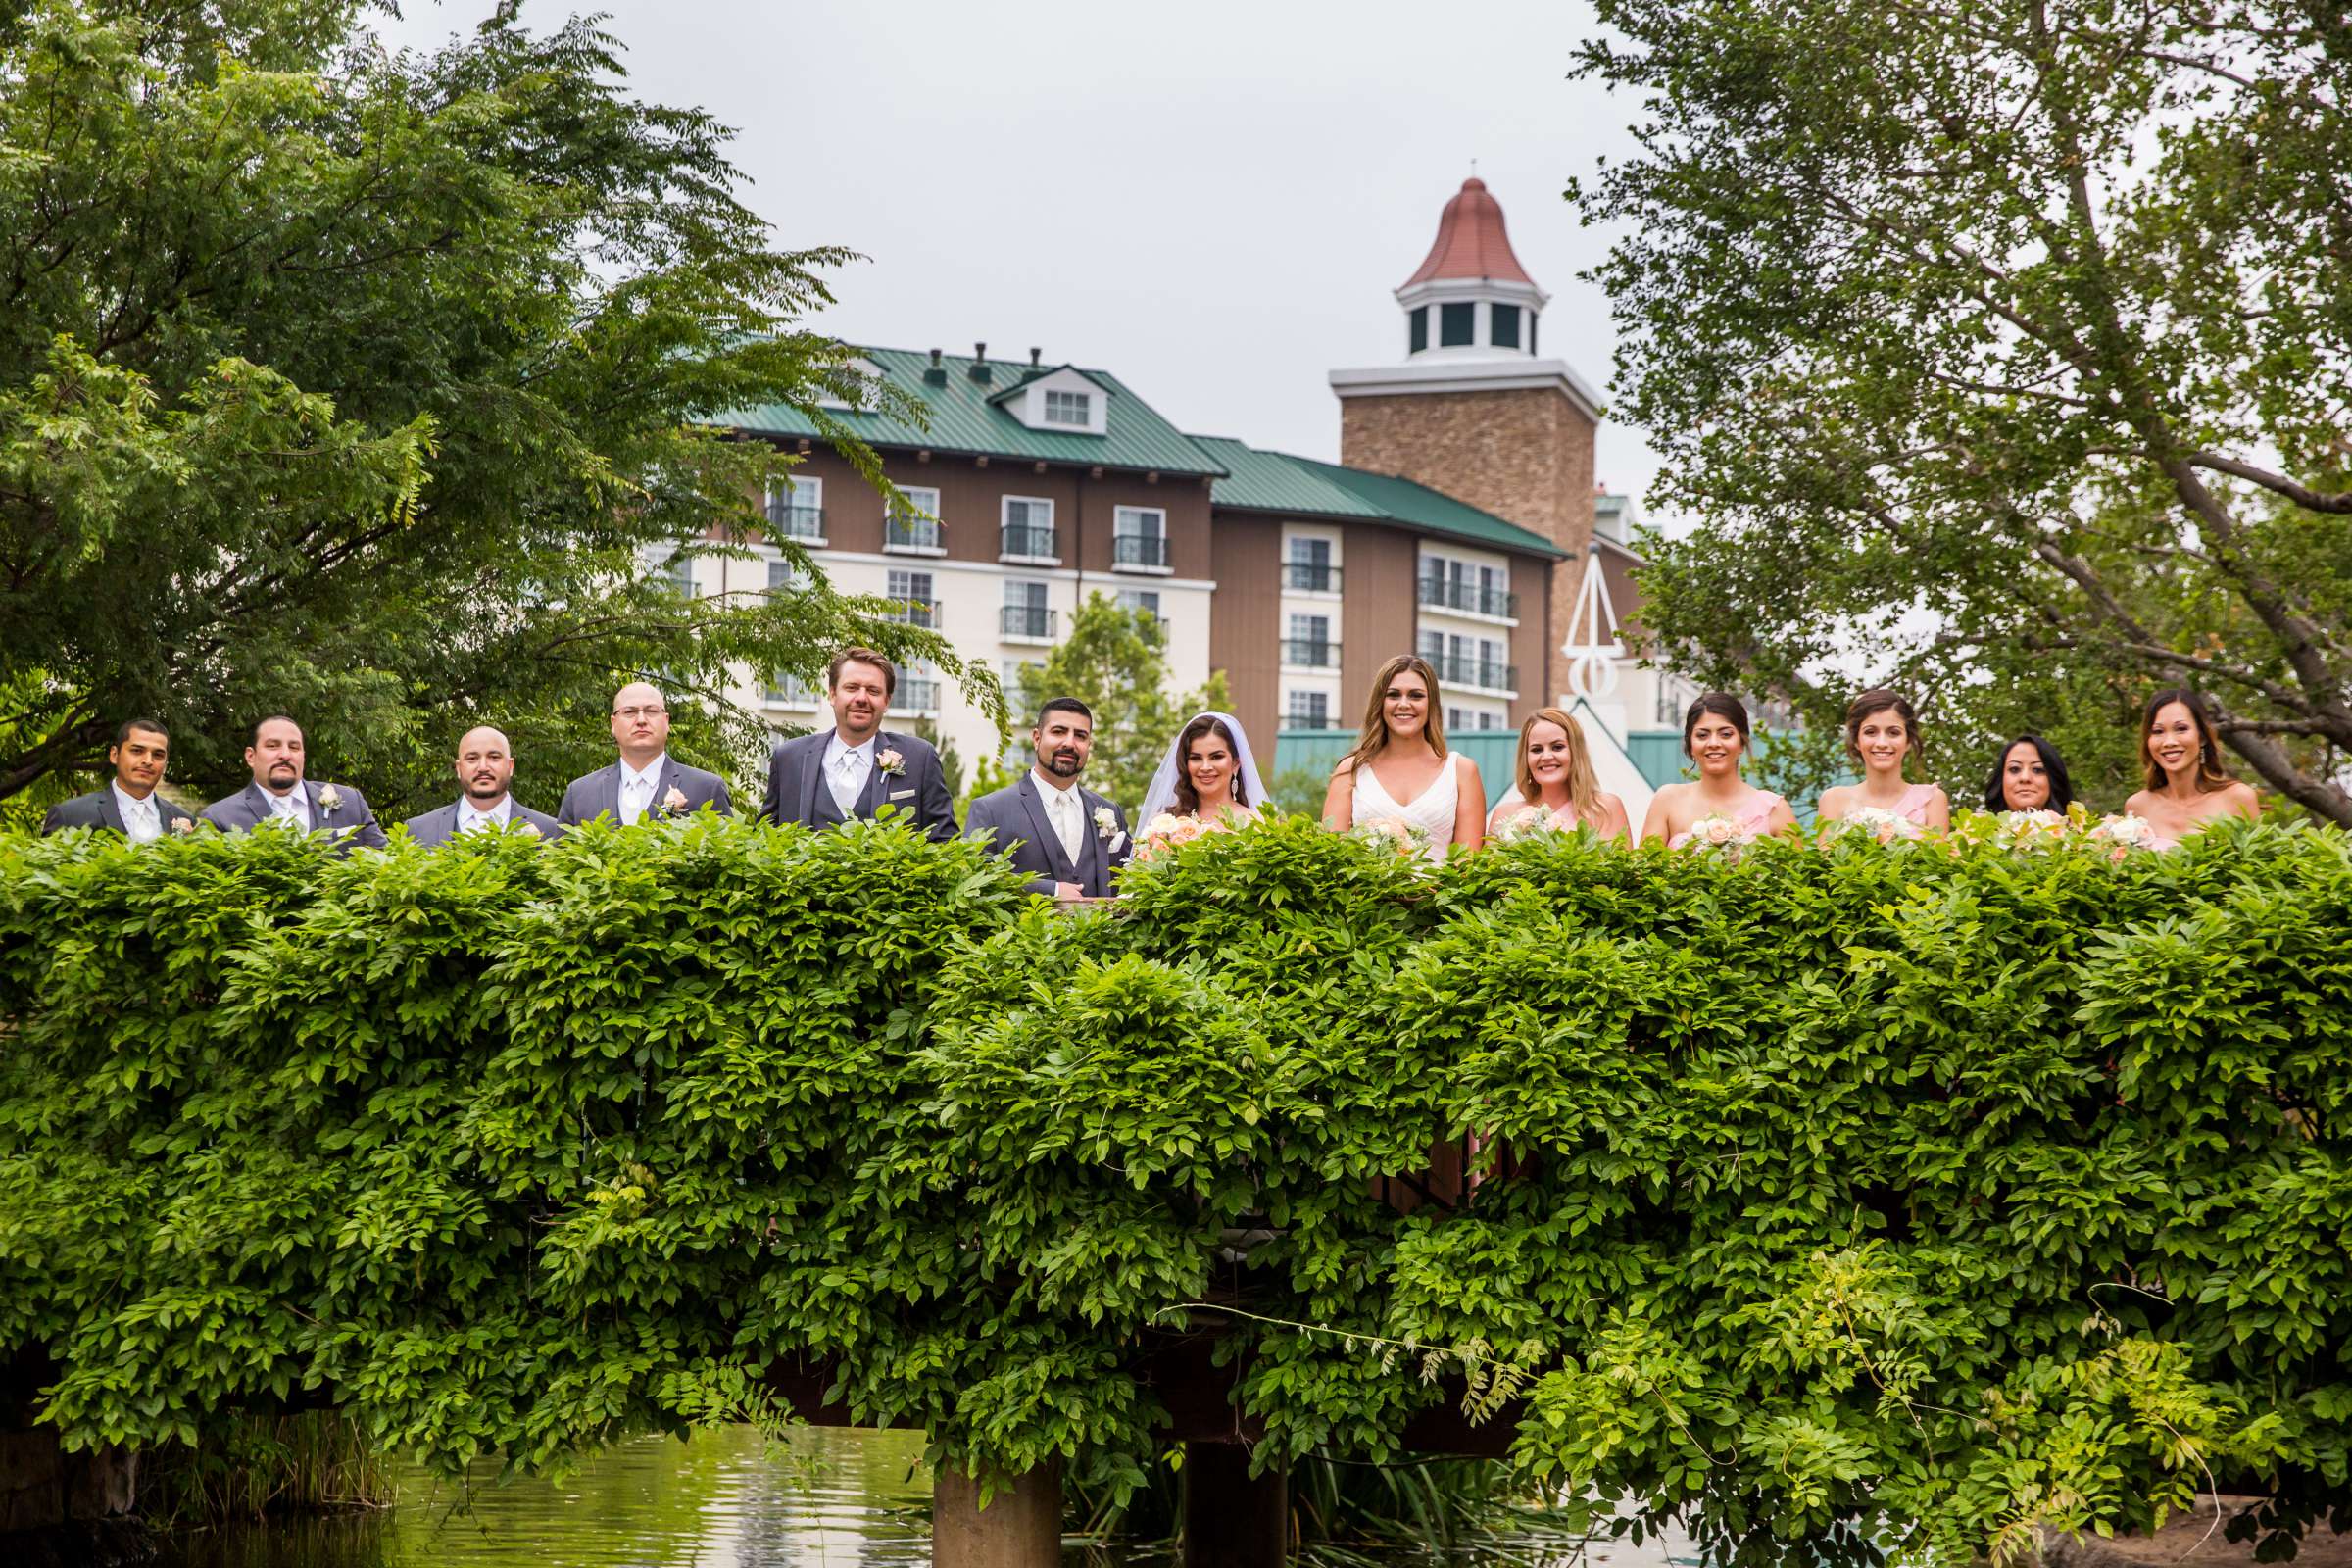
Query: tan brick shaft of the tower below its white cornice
[[1339, 388, 1594, 710]]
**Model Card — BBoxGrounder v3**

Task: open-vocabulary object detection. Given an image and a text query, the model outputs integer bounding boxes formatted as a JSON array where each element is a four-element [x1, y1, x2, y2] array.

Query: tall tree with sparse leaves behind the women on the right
[[1571, 0, 2352, 825]]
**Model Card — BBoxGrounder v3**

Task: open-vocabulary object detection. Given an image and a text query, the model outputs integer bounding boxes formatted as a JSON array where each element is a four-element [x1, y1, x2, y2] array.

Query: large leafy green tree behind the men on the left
[[0, 0, 995, 820]]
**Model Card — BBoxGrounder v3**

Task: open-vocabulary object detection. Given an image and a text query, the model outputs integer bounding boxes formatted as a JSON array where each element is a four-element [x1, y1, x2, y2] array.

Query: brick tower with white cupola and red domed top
[[1331, 178, 1601, 703]]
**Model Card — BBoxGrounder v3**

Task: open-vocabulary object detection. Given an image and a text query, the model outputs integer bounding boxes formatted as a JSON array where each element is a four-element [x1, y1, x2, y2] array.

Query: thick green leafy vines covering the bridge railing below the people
[[0, 820, 2352, 1563]]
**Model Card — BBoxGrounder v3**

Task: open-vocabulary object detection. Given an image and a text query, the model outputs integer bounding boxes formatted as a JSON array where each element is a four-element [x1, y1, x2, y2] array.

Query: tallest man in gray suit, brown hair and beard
[[760, 649, 955, 839]]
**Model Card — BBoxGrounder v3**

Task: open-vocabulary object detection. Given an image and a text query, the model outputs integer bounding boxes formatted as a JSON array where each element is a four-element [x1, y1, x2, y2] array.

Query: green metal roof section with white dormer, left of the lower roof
[[710, 348, 1225, 475]]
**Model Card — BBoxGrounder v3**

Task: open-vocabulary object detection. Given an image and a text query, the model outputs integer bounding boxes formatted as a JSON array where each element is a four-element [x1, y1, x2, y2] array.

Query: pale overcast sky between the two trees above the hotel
[[378, 0, 1656, 510]]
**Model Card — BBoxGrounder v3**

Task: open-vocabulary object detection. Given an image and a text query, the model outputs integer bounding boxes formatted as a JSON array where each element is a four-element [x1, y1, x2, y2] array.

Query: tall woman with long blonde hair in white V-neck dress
[[1324, 654, 1487, 860]]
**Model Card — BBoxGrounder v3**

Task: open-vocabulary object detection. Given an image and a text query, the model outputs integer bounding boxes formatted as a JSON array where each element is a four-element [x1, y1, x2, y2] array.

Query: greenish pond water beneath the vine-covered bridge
[[147, 1427, 1691, 1568]]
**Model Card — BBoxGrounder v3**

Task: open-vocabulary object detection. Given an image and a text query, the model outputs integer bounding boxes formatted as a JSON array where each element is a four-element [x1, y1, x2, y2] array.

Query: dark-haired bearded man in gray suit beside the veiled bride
[[964, 696, 1136, 898]]
